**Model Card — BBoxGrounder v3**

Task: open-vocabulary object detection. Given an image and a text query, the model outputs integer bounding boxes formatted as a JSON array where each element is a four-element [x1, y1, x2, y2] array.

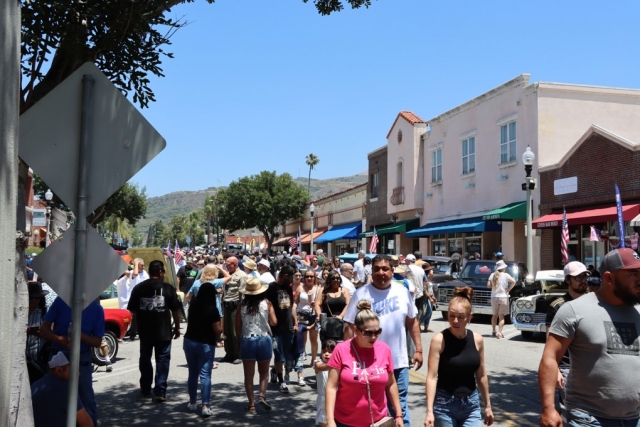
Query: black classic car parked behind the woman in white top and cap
[[435, 260, 540, 321]]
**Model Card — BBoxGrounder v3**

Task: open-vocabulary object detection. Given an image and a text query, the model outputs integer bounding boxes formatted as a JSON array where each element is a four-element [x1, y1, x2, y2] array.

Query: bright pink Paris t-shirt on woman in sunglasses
[[328, 339, 394, 427]]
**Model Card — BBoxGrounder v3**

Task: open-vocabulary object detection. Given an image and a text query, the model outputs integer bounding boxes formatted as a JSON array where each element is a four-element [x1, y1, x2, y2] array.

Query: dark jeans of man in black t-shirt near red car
[[138, 339, 171, 397]]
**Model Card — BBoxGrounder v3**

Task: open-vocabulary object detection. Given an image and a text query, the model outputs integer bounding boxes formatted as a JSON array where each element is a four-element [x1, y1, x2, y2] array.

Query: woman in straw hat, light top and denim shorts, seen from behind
[[236, 277, 277, 413]]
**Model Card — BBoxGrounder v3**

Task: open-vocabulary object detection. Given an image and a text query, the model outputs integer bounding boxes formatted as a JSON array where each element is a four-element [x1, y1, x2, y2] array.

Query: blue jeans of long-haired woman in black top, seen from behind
[[182, 338, 216, 406]]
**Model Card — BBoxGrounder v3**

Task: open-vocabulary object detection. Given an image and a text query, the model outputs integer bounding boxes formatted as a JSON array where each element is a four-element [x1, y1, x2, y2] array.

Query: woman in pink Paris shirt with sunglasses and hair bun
[[325, 300, 404, 427]]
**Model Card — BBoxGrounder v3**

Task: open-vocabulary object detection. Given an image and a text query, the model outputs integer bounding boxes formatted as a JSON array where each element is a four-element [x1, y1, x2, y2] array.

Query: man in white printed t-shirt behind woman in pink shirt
[[344, 255, 422, 427]]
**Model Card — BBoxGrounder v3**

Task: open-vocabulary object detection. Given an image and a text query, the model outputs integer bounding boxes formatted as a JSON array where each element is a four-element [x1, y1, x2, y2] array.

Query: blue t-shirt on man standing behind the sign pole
[[44, 297, 104, 361]]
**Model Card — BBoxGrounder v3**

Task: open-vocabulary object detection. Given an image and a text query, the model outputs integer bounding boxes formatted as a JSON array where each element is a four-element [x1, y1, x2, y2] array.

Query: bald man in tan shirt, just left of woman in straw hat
[[221, 256, 246, 365]]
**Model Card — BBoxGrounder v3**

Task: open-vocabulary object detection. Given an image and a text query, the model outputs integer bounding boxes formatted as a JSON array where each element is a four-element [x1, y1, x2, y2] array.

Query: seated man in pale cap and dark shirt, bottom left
[[31, 352, 93, 427]]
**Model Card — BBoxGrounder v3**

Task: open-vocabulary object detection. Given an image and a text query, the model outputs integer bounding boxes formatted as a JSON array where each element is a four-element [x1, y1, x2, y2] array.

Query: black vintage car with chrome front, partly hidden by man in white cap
[[512, 270, 567, 338]]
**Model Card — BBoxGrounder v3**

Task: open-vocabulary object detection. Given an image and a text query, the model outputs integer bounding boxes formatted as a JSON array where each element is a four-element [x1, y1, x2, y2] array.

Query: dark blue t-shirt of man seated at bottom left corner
[[31, 374, 84, 427]]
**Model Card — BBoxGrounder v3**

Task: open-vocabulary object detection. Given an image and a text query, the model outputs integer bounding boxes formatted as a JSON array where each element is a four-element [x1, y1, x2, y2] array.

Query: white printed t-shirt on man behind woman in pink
[[344, 281, 416, 369]]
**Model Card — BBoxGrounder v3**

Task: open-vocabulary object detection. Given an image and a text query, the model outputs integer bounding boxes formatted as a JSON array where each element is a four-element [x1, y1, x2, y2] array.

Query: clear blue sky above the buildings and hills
[[132, 0, 640, 196]]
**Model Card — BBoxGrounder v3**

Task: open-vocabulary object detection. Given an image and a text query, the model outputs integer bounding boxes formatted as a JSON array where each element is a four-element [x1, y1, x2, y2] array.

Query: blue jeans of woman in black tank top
[[433, 389, 482, 427]]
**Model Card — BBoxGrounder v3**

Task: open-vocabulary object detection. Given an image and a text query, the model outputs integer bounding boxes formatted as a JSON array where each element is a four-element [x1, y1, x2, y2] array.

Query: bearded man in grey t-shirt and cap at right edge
[[538, 248, 640, 427]]
